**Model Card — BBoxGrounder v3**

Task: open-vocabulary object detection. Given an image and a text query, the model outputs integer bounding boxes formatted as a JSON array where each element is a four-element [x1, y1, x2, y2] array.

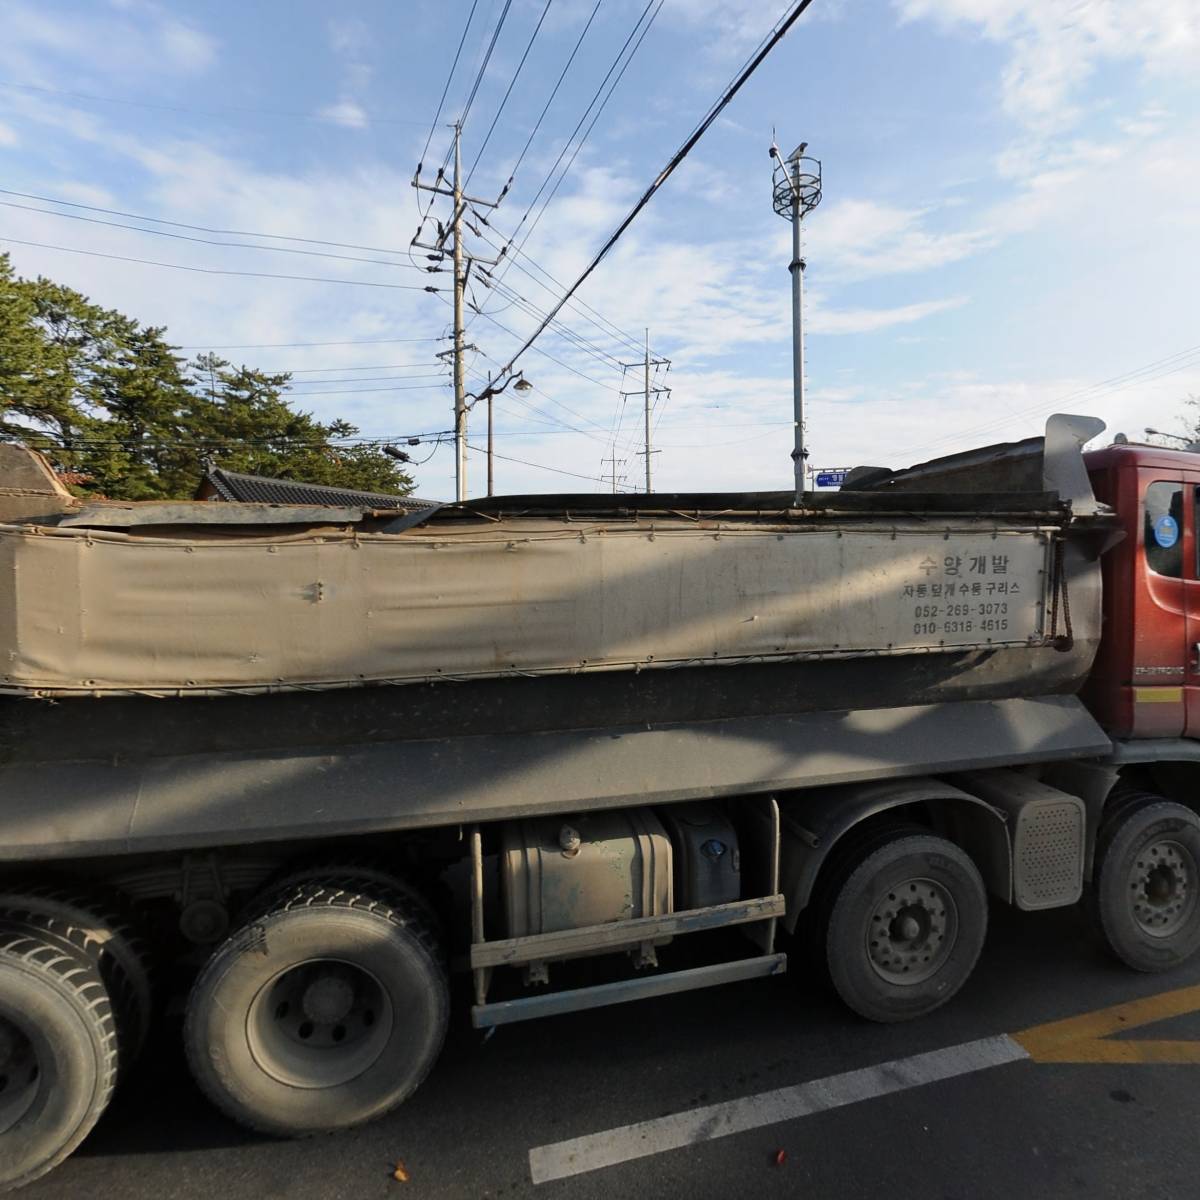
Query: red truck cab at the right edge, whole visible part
[[1084, 444, 1200, 738]]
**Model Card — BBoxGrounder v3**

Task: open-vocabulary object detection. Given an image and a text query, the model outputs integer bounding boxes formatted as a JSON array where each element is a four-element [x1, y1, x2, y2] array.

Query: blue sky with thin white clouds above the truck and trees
[[0, 0, 1200, 498]]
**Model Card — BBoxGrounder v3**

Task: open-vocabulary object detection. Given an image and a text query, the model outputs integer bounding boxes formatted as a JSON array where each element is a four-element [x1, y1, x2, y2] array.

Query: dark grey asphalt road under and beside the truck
[[22, 908, 1200, 1200]]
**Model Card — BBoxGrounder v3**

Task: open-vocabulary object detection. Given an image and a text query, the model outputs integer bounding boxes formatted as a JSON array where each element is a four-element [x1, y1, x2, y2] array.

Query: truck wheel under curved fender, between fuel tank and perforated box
[[824, 833, 988, 1021]]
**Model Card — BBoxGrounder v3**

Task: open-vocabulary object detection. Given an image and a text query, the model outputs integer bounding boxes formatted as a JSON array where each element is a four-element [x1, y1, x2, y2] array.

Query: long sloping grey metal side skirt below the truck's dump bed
[[0, 696, 1111, 862]]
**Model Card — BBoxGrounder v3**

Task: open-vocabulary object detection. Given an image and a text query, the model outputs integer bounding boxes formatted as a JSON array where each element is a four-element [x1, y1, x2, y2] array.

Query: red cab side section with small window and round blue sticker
[[1130, 468, 1200, 738]]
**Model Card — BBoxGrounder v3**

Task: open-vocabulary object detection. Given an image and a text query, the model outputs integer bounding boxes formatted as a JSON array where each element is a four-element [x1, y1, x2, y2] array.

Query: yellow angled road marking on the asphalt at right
[[1012, 984, 1200, 1063]]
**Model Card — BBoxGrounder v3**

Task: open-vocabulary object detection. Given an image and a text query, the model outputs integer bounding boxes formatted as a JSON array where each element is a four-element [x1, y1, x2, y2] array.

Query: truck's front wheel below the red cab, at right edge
[[1092, 796, 1200, 971]]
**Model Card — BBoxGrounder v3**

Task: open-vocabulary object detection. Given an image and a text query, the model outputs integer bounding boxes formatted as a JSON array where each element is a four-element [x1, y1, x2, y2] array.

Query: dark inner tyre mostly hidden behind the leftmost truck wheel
[[0, 883, 154, 1068]]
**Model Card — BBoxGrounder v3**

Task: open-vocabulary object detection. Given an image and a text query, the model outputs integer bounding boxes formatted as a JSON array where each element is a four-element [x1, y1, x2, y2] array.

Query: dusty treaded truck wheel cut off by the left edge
[[0, 926, 118, 1192]]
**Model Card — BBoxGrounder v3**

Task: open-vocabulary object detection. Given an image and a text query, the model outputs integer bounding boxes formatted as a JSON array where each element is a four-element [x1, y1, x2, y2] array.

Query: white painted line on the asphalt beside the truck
[[529, 1034, 1028, 1183]]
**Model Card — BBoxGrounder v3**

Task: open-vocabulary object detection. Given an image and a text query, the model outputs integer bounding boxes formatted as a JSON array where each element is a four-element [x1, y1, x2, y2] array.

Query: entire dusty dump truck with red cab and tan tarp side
[[0, 418, 1200, 1186]]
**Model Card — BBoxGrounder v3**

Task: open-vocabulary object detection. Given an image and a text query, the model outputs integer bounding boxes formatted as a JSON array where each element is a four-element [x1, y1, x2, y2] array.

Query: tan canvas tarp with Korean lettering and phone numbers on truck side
[[0, 518, 1052, 695]]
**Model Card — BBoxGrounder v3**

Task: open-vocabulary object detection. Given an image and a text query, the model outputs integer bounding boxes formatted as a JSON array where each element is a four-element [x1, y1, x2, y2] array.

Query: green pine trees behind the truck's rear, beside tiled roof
[[0, 254, 413, 500]]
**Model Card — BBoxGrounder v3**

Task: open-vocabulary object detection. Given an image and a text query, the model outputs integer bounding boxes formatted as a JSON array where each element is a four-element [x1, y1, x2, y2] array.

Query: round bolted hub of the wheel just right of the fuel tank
[[866, 878, 958, 986]]
